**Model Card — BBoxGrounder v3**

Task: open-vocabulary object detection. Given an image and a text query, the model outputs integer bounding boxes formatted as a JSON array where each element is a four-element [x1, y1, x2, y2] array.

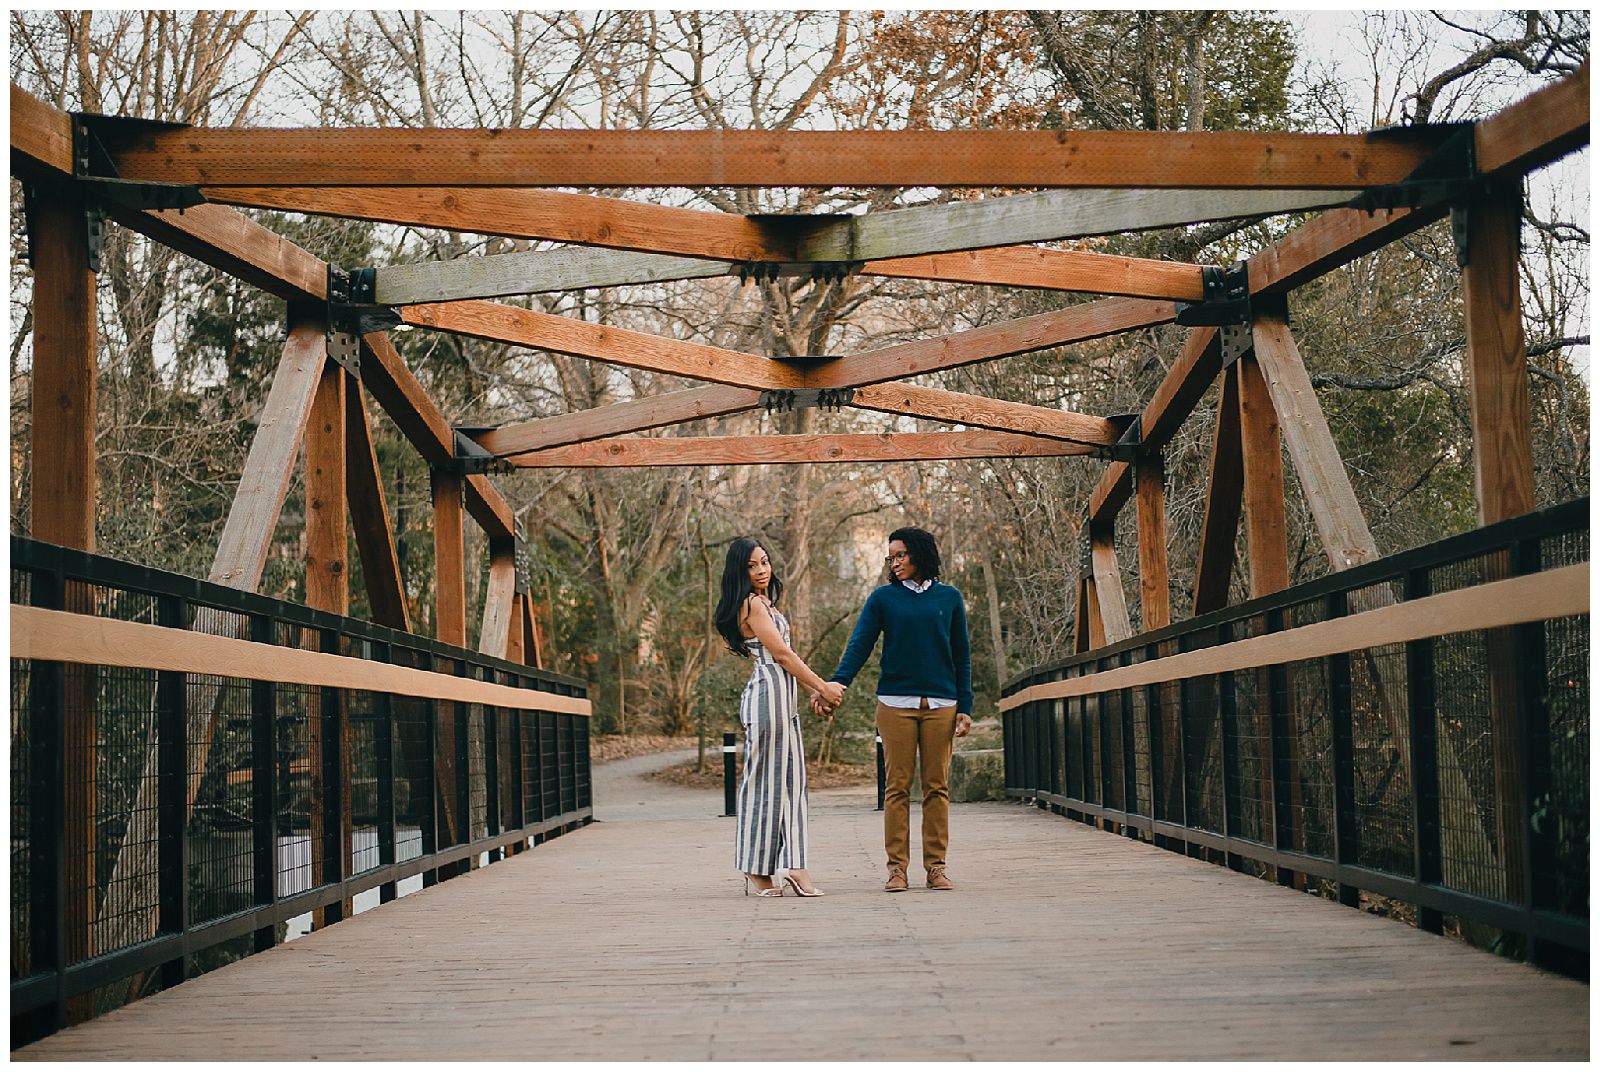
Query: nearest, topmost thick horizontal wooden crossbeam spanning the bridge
[[110, 128, 1442, 189]]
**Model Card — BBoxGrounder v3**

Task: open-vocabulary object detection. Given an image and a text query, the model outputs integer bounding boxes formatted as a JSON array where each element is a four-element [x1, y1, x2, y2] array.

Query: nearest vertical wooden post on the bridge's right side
[[1461, 178, 1534, 902]]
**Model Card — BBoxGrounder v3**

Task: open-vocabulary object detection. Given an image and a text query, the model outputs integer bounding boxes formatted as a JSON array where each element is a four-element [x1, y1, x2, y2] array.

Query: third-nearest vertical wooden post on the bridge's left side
[[430, 469, 467, 877]]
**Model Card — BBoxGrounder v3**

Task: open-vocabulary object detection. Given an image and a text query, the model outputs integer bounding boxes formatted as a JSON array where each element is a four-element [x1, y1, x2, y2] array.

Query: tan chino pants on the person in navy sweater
[[878, 699, 955, 869]]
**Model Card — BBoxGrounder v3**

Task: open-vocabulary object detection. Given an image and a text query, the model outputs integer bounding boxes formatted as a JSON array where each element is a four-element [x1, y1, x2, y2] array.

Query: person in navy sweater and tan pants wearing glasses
[[813, 528, 973, 893]]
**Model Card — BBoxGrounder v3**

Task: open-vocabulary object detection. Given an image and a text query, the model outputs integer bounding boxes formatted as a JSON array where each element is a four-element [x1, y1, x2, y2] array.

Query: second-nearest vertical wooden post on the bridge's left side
[[306, 362, 352, 926]]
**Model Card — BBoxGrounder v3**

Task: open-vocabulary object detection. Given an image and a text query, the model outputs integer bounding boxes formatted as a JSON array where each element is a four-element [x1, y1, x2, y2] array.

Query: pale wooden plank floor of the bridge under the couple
[[13, 760, 1589, 1061]]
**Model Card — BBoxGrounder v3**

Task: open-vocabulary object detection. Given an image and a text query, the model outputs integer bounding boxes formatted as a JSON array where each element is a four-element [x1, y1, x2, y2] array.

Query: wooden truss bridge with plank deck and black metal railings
[[11, 66, 1589, 1059]]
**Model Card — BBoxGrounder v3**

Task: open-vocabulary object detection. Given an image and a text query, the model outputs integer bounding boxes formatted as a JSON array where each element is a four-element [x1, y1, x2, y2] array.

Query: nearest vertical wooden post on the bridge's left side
[[29, 187, 99, 972]]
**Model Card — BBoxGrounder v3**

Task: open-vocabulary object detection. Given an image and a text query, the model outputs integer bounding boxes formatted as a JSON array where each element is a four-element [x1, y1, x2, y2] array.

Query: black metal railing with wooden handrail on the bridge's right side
[[1002, 499, 1589, 978]]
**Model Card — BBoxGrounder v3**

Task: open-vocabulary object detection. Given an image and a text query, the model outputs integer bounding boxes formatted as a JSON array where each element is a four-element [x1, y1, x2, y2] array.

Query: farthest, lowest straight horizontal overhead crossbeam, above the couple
[[510, 432, 1093, 469]]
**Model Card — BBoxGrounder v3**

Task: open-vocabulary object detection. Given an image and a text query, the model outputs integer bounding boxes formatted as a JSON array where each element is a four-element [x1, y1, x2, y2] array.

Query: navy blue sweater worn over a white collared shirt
[[832, 581, 973, 714]]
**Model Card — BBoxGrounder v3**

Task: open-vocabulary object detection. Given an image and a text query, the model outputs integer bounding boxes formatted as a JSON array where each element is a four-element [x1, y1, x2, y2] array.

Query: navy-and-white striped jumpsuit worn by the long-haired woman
[[733, 610, 806, 875]]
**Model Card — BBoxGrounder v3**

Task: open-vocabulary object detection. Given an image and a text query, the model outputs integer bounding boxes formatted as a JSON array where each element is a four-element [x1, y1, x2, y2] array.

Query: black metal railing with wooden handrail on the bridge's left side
[[11, 538, 594, 1046]]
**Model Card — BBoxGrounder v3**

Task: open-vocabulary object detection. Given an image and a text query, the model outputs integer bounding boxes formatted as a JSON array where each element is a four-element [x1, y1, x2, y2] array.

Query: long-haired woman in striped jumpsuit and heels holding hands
[[715, 538, 843, 898]]
